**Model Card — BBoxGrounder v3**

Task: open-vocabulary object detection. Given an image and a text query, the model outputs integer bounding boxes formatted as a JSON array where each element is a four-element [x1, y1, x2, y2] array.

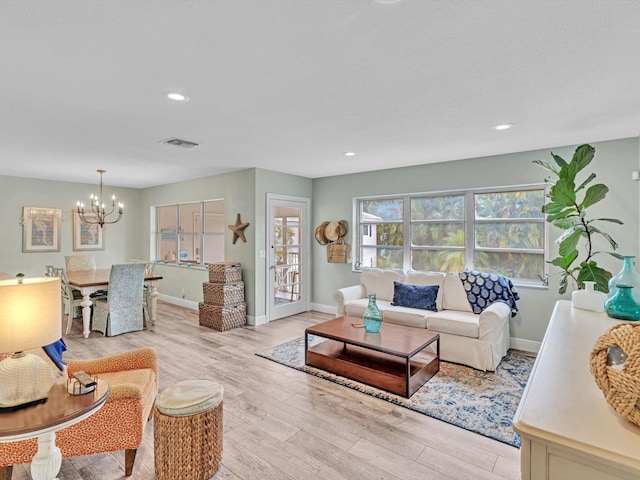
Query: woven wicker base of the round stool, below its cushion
[[153, 402, 223, 480]]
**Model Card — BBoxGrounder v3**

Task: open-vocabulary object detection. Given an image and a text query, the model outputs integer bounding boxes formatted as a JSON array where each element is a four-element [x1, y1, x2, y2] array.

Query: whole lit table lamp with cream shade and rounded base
[[0, 275, 62, 411]]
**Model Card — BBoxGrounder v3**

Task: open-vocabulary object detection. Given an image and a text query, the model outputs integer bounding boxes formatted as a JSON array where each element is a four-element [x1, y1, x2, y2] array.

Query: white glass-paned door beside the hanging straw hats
[[266, 195, 310, 321]]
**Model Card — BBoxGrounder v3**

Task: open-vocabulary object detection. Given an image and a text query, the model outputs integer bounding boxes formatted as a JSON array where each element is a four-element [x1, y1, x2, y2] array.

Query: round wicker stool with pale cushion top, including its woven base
[[153, 380, 224, 480]]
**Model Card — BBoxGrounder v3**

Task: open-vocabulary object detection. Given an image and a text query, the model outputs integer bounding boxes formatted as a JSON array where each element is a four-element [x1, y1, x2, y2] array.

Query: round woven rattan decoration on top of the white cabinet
[[589, 323, 640, 426]]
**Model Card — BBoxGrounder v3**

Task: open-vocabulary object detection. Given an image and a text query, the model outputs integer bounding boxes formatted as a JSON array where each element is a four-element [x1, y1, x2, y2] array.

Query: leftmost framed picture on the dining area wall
[[22, 207, 62, 253]]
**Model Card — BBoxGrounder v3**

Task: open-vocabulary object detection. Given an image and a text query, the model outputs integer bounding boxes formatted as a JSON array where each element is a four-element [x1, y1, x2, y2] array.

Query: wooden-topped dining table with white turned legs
[[67, 268, 162, 338]]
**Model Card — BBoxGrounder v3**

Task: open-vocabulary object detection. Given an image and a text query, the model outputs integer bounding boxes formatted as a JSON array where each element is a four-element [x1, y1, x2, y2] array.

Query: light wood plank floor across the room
[[13, 302, 520, 480]]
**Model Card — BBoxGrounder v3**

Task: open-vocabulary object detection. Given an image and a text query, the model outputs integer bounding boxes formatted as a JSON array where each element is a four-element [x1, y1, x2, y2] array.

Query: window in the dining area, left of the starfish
[[154, 200, 225, 265]]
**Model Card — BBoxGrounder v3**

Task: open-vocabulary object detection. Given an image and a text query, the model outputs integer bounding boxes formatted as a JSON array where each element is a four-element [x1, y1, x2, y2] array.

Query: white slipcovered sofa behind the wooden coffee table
[[336, 268, 511, 371]]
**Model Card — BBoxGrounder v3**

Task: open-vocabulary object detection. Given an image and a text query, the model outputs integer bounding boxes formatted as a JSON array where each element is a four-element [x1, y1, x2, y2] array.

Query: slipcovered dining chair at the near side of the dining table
[[92, 263, 145, 336]]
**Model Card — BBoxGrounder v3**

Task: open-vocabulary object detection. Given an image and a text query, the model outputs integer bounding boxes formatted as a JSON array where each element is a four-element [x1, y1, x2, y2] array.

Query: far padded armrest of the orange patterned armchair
[[67, 347, 158, 378]]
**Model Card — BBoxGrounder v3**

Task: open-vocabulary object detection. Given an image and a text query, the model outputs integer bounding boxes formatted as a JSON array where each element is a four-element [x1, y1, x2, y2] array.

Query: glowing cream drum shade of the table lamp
[[0, 277, 62, 353]]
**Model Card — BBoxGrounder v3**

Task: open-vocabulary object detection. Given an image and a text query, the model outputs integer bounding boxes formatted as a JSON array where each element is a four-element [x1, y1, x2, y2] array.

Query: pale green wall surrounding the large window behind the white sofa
[[313, 138, 640, 341]]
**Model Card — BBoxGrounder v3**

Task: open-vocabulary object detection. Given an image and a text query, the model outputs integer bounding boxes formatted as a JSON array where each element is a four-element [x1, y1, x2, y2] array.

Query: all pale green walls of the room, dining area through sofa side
[[0, 138, 640, 342]]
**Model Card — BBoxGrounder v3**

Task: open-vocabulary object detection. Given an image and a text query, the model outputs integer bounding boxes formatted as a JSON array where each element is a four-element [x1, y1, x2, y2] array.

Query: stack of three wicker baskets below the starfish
[[199, 262, 247, 332]]
